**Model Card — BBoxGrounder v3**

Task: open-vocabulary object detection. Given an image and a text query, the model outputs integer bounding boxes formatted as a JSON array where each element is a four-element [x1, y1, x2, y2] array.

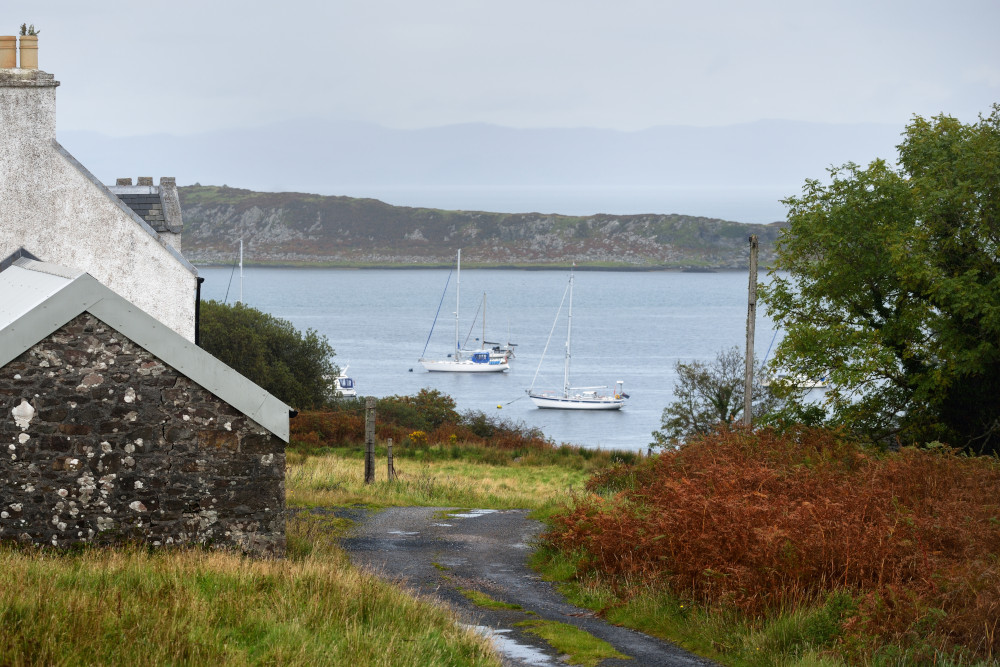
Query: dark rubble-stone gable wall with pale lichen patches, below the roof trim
[[0, 313, 285, 557]]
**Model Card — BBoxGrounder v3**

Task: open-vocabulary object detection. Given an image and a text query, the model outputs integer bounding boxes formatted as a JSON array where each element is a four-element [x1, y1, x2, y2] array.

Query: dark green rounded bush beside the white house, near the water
[[200, 301, 338, 409]]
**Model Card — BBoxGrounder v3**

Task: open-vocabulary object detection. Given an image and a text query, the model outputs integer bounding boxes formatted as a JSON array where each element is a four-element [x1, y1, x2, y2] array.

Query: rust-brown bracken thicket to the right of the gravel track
[[545, 428, 1000, 658]]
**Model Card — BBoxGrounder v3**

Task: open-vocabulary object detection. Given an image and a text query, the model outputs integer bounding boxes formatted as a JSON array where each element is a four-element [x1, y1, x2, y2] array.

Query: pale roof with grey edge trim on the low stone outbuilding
[[0, 257, 290, 442]]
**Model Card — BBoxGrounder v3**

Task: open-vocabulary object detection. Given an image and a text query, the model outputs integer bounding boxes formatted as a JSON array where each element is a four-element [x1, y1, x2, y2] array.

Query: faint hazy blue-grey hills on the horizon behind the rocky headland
[[59, 118, 903, 223]]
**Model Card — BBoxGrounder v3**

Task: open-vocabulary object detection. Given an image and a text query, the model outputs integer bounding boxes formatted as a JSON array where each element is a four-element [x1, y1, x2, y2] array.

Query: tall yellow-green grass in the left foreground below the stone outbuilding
[[0, 546, 499, 666]]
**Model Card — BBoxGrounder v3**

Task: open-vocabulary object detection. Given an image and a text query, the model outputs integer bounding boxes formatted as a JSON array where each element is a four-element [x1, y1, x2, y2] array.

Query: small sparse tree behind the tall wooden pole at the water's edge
[[653, 347, 782, 447]]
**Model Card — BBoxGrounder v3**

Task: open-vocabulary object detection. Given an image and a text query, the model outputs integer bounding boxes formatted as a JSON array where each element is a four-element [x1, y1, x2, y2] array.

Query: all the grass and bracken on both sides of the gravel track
[[0, 392, 1000, 667]]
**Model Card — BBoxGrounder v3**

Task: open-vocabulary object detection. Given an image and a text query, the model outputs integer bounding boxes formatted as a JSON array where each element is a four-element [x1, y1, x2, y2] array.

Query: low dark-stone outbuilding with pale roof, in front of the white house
[[0, 258, 289, 555]]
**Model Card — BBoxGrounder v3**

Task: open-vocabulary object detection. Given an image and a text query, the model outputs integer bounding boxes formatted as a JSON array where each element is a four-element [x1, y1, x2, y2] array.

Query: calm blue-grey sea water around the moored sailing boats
[[198, 267, 776, 451]]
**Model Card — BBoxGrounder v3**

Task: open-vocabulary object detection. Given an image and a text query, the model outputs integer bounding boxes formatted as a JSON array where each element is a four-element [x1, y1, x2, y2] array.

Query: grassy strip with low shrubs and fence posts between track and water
[[287, 390, 637, 514]]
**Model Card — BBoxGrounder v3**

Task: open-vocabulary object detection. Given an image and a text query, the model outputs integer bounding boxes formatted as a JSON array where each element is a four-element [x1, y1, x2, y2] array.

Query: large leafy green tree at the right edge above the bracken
[[762, 105, 1000, 453]]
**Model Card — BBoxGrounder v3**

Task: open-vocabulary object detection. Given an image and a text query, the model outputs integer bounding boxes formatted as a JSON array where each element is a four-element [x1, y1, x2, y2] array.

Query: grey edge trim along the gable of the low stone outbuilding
[[0, 266, 290, 442]]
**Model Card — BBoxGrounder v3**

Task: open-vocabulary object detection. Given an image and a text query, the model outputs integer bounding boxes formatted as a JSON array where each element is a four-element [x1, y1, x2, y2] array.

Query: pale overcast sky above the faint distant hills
[[21, 0, 1000, 136]]
